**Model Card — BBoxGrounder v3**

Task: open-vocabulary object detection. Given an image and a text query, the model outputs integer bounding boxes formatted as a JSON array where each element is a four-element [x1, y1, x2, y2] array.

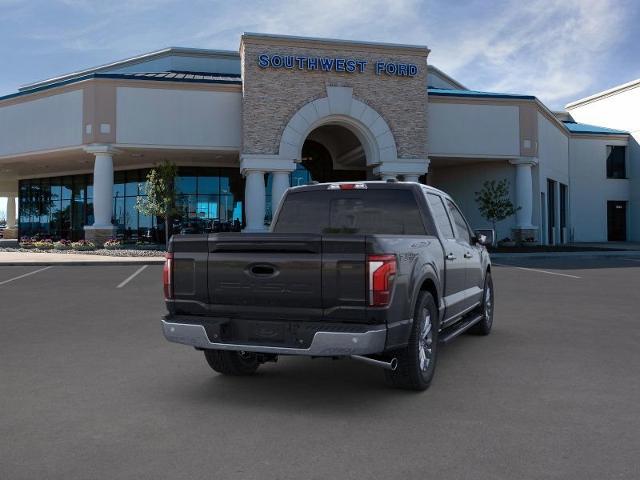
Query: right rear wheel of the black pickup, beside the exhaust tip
[[385, 292, 440, 390]]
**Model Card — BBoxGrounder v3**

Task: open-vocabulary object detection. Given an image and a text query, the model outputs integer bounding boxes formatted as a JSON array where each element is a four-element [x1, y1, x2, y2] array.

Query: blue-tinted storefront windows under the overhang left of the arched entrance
[[19, 167, 244, 243]]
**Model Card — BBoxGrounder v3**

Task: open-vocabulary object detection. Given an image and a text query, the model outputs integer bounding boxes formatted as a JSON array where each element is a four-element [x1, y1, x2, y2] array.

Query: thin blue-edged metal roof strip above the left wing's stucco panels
[[0, 71, 242, 100]]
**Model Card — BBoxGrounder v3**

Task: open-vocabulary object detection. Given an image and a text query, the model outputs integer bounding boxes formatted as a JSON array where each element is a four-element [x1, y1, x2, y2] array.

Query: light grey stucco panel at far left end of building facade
[[0, 90, 82, 156]]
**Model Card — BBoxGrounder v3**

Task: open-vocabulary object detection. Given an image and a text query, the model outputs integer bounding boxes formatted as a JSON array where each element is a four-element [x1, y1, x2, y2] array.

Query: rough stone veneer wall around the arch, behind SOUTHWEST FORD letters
[[240, 36, 428, 159]]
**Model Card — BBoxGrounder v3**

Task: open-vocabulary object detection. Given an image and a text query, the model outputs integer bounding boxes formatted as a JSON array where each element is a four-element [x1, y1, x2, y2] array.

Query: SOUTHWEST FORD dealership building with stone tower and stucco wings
[[0, 33, 640, 244]]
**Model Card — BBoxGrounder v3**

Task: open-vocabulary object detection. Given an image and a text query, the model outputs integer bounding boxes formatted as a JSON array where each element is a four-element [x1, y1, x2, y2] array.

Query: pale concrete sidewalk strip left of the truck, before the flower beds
[[0, 252, 164, 267]]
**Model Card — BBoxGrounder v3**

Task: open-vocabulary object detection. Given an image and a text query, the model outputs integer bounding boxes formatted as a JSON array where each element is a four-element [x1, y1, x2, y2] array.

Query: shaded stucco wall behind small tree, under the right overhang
[[429, 161, 515, 240]]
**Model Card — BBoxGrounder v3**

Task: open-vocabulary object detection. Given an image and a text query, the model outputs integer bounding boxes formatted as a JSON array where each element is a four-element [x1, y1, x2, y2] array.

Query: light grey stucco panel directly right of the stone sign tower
[[427, 101, 520, 157]]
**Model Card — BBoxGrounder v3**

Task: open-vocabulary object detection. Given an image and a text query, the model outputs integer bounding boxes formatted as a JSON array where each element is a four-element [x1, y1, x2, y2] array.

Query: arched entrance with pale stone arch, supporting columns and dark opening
[[240, 86, 427, 232]]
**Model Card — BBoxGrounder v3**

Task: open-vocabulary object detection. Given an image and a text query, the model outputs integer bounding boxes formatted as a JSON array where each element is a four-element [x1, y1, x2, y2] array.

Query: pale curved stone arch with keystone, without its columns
[[278, 86, 398, 166]]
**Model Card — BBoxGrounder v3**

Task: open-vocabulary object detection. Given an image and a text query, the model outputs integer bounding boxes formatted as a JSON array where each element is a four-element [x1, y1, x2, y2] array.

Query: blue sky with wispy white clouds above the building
[[0, 0, 640, 218]]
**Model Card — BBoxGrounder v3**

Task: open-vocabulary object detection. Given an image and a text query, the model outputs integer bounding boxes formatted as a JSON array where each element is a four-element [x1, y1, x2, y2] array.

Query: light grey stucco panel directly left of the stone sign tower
[[116, 87, 242, 150]]
